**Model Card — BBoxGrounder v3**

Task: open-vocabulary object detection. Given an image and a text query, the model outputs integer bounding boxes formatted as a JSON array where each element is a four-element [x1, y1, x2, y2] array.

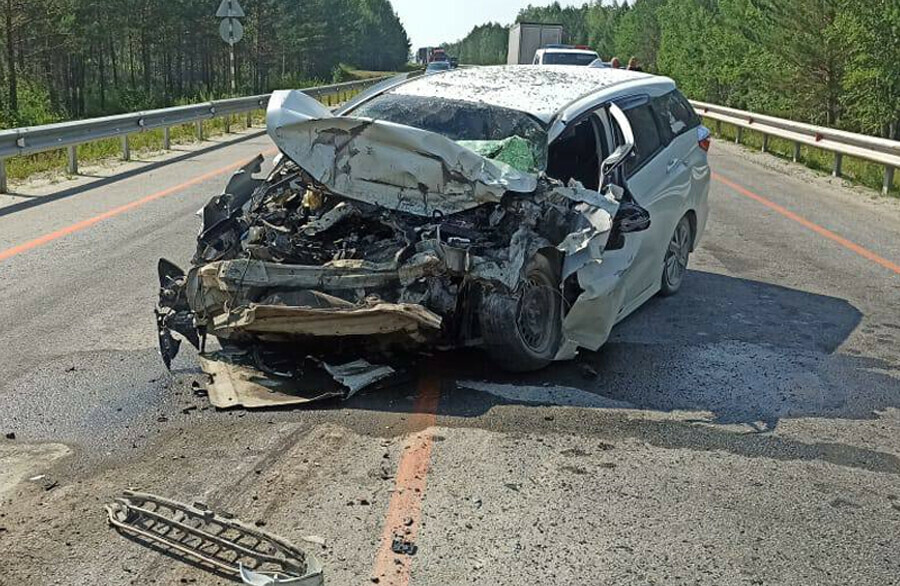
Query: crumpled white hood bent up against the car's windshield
[[266, 90, 537, 217]]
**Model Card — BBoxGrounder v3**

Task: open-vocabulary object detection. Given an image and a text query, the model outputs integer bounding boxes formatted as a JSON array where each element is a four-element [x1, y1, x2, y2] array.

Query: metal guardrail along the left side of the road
[[0, 77, 386, 193]]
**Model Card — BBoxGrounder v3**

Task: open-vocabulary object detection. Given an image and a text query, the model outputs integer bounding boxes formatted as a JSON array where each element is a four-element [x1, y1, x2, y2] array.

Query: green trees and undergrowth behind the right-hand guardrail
[[445, 0, 900, 192]]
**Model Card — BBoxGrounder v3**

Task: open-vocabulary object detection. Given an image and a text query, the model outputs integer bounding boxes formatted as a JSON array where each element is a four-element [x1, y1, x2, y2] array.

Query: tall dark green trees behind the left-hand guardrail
[[0, 0, 410, 128]]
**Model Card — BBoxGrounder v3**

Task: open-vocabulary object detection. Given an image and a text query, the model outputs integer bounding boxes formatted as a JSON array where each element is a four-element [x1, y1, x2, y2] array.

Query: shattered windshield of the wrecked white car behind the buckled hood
[[352, 94, 547, 173]]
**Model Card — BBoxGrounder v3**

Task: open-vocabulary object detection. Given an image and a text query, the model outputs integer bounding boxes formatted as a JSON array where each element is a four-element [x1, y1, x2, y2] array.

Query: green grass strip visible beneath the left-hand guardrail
[[6, 84, 370, 181]]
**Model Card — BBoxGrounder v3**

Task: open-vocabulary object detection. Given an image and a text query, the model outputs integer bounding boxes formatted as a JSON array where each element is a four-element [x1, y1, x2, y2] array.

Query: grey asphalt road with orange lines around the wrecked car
[[0, 134, 900, 586]]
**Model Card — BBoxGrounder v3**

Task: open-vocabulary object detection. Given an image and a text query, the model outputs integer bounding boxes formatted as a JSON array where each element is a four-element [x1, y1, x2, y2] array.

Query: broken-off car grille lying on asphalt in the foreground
[[106, 491, 325, 586]]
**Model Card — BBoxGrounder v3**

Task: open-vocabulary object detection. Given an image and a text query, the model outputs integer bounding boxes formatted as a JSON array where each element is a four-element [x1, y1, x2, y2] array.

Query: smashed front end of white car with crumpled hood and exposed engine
[[156, 86, 629, 408]]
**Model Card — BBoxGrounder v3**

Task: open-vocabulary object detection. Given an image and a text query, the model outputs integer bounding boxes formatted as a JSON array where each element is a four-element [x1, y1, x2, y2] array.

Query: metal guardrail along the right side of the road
[[691, 100, 900, 194]]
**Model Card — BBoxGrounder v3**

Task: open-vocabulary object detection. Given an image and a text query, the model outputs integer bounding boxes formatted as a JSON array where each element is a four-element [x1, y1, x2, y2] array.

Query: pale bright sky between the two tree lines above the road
[[391, 0, 585, 51]]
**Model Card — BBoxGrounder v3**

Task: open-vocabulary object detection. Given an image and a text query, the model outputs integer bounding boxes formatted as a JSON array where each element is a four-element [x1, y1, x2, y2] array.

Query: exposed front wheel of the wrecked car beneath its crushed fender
[[479, 255, 562, 372]]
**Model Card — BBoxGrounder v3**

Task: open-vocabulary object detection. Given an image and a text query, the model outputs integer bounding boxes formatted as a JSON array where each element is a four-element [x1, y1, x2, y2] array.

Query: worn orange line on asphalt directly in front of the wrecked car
[[372, 371, 441, 586]]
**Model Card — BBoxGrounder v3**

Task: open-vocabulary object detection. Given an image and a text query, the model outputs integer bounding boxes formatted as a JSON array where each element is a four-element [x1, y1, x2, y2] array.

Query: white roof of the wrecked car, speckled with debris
[[384, 65, 675, 124]]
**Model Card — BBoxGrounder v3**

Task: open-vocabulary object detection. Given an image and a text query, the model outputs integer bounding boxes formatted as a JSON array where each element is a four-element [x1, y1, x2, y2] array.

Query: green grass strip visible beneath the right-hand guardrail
[[703, 118, 900, 197]]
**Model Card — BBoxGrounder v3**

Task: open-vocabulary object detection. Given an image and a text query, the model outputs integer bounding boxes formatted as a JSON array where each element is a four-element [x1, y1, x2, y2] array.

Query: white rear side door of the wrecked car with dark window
[[620, 98, 691, 306]]
